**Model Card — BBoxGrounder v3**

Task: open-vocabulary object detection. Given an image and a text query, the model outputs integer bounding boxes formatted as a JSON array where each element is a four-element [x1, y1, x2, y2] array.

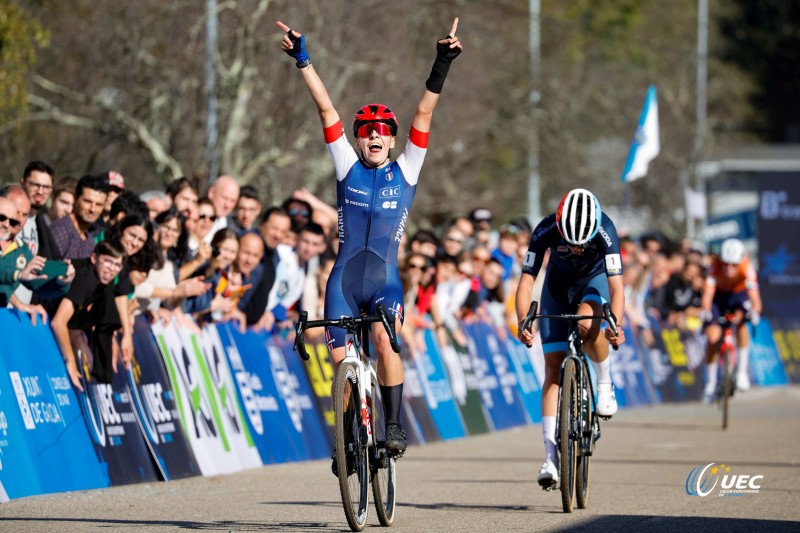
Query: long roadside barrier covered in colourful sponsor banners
[[0, 309, 800, 501]]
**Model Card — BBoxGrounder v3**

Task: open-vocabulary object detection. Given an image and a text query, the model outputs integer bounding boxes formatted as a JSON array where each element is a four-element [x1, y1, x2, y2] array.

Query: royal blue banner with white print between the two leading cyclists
[[464, 322, 527, 430]]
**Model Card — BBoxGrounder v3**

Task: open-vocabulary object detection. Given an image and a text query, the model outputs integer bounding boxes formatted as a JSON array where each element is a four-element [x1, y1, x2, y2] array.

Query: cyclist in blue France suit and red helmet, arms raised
[[277, 18, 462, 457]]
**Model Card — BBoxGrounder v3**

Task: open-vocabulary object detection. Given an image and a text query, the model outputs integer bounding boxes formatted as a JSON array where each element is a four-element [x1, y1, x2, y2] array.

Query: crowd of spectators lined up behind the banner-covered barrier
[[0, 161, 707, 387]]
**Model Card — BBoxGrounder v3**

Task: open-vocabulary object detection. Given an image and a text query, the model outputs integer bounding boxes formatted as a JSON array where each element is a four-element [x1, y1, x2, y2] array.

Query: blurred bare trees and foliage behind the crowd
[[0, 0, 800, 234]]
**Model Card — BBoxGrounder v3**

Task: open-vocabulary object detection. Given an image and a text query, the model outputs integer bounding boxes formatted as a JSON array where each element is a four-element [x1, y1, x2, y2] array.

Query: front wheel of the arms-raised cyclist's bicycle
[[334, 361, 369, 531]]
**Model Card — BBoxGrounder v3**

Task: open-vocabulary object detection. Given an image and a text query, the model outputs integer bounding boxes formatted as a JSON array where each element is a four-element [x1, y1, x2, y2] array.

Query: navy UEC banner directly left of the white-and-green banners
[[127, 316, 201, 480]]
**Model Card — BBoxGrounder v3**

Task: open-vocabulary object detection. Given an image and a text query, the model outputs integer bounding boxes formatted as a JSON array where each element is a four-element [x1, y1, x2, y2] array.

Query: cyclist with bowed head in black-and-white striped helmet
[[516, 189, 625, 488]]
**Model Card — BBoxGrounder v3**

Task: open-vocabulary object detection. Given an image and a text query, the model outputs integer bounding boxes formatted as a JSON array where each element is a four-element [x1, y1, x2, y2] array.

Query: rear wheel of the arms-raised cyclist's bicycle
[[370, 372, 397, 527]]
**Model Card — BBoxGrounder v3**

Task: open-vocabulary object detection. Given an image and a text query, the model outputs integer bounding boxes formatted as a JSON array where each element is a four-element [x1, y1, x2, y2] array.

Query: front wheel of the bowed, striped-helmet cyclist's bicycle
[[558, 359, 580, 513]]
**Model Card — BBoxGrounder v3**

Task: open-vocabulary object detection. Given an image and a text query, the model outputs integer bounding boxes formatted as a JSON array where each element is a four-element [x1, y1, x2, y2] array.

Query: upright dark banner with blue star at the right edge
[[758, 172, 800, 318]]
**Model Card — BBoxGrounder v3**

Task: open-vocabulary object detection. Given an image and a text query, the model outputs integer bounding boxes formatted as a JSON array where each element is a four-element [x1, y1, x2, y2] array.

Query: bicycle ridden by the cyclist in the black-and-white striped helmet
[[522, 301, 617, 513]]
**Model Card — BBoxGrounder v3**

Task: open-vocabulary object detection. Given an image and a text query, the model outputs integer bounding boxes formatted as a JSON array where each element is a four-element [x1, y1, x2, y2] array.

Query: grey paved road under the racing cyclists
[[0, 387, 800, 533]]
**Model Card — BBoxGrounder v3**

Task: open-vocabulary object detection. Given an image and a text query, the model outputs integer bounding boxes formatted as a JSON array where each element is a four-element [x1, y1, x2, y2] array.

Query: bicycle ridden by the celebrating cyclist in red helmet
[[294, 305, 400, 531]]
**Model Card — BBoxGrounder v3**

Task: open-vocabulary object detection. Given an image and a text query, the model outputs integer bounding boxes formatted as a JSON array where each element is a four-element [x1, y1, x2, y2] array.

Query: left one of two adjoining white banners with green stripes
[[152, 317, 241, 476]]
